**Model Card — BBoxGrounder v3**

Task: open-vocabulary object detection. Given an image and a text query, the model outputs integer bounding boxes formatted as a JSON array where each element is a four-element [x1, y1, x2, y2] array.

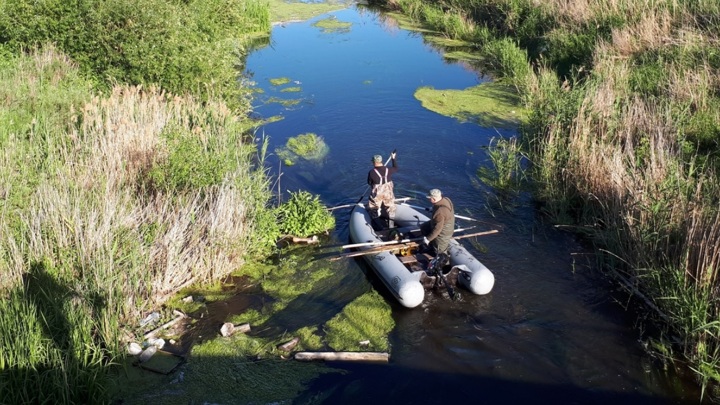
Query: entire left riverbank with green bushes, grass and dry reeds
[[0, 0, 279, 403]]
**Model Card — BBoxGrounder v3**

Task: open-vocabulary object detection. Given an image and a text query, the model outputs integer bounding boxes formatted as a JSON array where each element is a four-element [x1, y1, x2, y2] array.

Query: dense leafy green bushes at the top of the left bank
[[0, 0, 270, 111]]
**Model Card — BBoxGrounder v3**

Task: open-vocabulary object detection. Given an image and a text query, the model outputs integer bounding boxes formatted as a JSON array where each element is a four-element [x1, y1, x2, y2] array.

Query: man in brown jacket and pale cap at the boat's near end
[[420, 188, 455, 253]]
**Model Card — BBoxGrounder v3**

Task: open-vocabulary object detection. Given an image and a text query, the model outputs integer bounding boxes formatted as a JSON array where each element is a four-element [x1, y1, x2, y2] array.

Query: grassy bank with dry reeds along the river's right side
[[374, 0, 720, 396]]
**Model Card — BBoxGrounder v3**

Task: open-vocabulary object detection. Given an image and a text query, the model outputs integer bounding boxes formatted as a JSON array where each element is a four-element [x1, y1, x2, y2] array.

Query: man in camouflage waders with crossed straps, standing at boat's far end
[[367, 152, 398, 228]]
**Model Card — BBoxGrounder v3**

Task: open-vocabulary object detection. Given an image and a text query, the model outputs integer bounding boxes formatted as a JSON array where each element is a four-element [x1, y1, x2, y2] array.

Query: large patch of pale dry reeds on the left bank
[[16, 81, 252, 316]]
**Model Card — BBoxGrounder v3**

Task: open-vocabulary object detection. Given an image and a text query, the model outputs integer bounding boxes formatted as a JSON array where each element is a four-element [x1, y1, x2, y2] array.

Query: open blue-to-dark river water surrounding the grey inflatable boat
[[242, 3, 699, 404]]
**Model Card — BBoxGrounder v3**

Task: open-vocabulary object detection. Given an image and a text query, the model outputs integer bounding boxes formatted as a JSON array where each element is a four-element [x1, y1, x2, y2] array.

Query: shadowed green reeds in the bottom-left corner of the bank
[[0, 262, 109, 404]]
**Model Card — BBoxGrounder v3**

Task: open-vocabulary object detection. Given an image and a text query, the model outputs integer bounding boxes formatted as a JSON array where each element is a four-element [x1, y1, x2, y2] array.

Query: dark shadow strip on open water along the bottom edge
[[293, 364, 697, 405]]
